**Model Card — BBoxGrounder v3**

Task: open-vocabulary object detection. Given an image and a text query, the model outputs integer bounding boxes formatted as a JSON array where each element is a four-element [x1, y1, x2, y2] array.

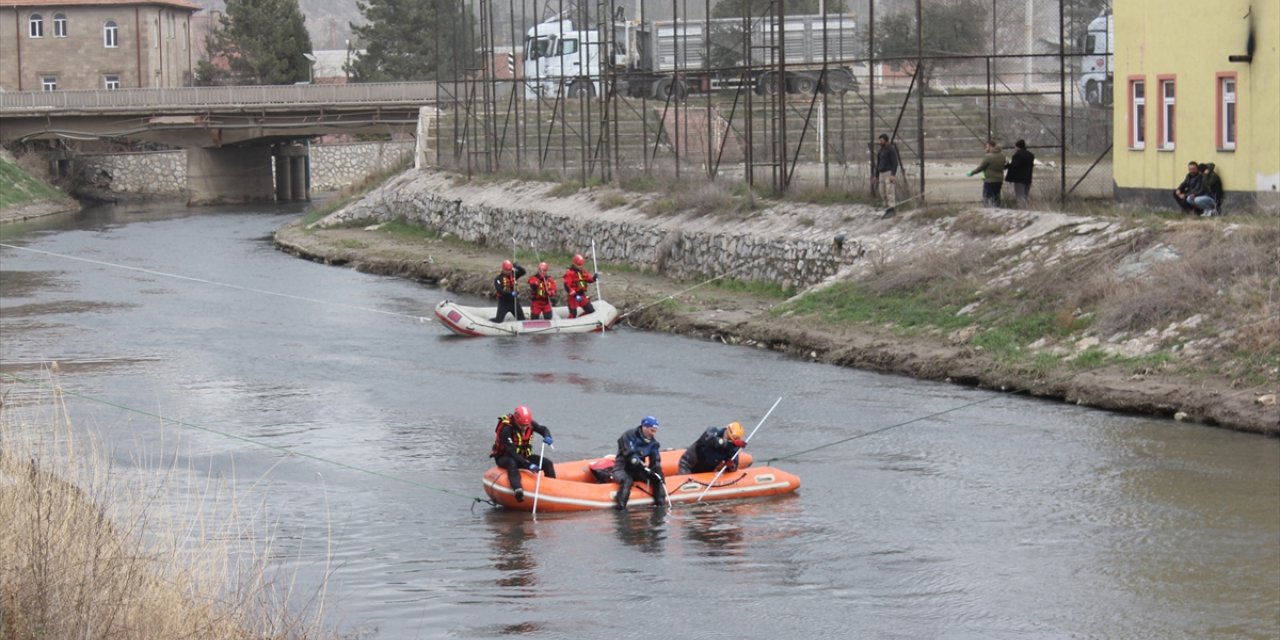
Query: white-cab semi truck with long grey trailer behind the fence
[[524, 14, 860, 100]]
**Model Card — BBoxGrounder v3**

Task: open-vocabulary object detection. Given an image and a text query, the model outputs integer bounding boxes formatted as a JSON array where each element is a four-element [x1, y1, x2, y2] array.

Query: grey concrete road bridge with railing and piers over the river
[[0, 82, 439, 205]]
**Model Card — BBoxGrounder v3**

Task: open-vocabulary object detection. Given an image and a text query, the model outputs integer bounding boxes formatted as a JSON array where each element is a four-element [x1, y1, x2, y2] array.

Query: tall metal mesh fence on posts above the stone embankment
[[434, 0, 1112, 206]]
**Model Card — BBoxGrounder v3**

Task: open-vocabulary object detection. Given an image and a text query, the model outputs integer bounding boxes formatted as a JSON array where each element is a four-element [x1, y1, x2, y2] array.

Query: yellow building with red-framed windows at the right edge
[[1112, 0, 1280, 212]]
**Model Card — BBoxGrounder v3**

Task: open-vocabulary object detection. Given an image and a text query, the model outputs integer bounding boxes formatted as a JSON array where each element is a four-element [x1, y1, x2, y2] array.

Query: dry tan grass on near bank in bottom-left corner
[[0, 373, 337, 640]]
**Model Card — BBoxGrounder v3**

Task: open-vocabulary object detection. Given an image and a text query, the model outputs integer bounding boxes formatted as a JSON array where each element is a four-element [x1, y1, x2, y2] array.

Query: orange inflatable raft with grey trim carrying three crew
[[484, 449, 800, 512]]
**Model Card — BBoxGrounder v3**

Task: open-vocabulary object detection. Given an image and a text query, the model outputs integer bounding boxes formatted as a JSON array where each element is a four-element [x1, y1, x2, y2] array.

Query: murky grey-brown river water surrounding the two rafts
[[0, 206, 1280, 640]]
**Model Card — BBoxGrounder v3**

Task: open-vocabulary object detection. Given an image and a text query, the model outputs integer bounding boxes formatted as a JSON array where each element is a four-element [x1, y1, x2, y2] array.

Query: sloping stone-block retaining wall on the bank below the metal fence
[[320, 170, 878, 287]]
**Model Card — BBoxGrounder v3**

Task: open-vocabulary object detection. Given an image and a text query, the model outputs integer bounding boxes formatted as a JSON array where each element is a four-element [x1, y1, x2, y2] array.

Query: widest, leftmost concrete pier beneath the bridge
[[187, 147, 275, 205]]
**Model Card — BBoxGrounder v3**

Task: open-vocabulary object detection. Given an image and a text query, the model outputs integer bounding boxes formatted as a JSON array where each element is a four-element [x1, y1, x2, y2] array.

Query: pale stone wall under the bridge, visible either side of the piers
[[77, 141, 413, 197]]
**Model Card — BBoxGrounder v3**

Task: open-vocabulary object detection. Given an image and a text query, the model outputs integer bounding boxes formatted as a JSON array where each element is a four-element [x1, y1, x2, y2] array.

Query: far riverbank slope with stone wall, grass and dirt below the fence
[[276, 172, 1280, 435]]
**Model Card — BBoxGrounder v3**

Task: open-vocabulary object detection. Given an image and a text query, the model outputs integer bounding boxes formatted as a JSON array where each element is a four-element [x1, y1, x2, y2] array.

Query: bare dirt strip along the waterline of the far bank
[[276, 218, 1280, 435]]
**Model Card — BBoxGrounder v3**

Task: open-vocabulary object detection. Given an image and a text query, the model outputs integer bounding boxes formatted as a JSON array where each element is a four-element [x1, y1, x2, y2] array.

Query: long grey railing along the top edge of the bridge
[[0, 82, 436, 111]]
